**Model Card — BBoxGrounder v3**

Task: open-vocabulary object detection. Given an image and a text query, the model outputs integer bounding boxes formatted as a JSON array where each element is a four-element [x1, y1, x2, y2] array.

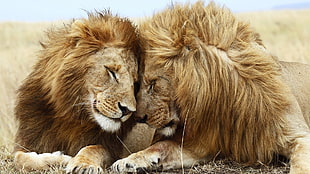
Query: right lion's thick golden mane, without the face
[[140, 2, 289, 163]]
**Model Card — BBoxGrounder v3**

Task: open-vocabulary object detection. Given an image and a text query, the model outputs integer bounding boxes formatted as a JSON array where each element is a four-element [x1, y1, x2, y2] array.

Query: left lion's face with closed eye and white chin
[[86, 47, 138, 132]]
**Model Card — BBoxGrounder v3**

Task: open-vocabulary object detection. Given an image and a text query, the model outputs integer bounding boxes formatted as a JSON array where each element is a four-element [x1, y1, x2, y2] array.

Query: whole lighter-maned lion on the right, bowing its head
[[112, 2, 310, 173]]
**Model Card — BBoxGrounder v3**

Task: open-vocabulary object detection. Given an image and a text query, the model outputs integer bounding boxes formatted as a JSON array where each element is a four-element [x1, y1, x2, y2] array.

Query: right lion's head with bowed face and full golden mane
[[137, 2, 288, 161]]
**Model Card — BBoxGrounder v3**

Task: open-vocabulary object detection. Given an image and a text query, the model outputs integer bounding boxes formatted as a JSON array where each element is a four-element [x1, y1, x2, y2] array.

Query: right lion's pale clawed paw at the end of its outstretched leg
[[111, 154, 162, 173]]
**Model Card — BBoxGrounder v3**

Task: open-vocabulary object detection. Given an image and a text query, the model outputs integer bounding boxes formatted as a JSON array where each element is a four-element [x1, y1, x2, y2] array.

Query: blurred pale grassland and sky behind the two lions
[[0, 0, 310, 173]]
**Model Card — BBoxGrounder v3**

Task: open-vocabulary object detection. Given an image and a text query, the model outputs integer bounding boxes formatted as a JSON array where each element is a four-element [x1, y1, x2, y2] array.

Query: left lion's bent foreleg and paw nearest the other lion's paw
[[66, 145, 112, 173]]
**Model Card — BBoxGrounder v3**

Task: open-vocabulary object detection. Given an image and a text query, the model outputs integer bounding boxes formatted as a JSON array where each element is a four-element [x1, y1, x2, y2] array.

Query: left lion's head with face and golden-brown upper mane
[[37, 12, 138, 132]]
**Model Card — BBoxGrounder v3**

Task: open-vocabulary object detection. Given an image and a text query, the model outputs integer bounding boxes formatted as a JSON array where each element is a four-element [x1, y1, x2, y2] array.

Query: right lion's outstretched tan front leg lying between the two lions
[[112, 141, 197, 172]]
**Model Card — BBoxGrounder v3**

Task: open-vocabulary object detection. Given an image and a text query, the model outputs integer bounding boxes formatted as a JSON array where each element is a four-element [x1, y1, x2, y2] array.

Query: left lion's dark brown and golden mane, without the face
[[15, 11, 138, 158]]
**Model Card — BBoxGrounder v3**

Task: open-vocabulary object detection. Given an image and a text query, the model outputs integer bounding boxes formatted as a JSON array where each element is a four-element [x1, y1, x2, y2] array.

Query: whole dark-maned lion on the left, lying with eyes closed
[[14, 11, 154, 173]]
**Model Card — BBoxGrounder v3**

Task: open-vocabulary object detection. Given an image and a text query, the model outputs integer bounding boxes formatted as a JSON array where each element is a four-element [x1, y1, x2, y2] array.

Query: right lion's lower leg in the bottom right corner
[[290, 135, 310, 174]]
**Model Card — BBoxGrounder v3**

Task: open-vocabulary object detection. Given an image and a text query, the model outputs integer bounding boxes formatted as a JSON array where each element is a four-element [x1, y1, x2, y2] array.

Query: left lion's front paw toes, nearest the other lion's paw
[[66, 159, 103, 174]]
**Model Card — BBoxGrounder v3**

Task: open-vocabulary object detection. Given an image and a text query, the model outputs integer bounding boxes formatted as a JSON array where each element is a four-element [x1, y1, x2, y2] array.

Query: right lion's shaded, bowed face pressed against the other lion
[[136, 61, 179, 136]]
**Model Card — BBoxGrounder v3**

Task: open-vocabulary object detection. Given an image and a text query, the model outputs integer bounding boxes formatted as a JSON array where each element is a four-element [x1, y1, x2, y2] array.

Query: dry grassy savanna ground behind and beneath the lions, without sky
[[0, 10, 310, 174]]
